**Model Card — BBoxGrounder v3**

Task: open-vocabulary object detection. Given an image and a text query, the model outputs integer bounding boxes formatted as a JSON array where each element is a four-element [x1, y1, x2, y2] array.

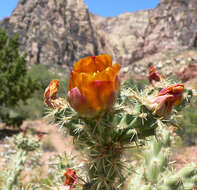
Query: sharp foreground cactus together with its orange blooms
[[44, 55, 192, 190]]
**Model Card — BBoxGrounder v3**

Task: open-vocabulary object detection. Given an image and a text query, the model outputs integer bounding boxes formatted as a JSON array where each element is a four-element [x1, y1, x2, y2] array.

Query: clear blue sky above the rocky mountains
[[0, 0, 160, 20]]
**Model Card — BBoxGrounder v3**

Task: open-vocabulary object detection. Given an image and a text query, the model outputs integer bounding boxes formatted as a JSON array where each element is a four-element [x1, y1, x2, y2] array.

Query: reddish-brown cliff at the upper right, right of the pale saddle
[[133, 0, 197, 60]]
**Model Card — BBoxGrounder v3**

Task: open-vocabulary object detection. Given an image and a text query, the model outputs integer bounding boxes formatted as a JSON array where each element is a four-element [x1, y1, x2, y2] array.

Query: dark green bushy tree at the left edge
[[0, 30, 38, 126]]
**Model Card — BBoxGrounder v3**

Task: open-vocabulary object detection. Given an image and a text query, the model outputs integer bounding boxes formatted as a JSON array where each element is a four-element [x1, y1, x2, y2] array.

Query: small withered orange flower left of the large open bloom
[[44, 79, 64, 109]]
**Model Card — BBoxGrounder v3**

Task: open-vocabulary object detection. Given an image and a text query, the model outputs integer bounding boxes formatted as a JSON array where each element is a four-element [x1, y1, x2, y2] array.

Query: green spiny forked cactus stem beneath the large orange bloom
[[45, 83, 191, 190]]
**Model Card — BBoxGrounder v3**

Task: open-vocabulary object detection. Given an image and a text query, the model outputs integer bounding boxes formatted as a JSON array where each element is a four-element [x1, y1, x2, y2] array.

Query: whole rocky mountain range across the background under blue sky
[[0, 0, 197, 75]]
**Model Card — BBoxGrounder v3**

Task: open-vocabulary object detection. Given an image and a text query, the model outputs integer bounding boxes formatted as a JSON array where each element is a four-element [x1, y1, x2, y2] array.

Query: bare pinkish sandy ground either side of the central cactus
[[23, 120, 197, 169]]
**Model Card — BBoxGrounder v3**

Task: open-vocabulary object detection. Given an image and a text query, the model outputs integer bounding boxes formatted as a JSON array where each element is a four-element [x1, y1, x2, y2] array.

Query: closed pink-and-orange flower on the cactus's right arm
[[147, 84, 184, 118]]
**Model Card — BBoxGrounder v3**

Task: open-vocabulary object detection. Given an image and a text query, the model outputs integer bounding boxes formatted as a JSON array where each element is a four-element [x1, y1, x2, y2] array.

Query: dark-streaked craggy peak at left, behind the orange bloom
[[1, 0, 111, 69]]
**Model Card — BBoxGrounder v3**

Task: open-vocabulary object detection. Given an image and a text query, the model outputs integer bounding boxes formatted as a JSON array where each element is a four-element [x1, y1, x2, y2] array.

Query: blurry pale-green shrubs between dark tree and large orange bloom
[[20, 64, 68, 119]]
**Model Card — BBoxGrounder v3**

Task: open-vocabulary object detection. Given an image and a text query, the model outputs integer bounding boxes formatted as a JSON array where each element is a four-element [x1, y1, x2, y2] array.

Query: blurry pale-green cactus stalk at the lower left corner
[[3, 134, 39, 190]]
